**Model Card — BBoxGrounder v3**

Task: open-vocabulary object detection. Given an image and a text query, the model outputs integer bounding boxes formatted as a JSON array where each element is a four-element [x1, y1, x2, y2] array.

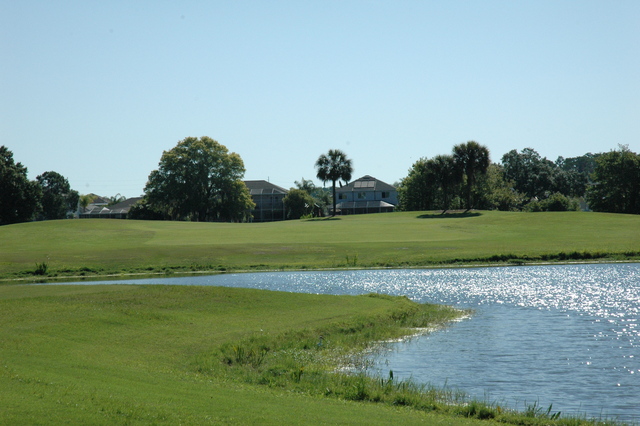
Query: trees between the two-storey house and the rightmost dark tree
[[398, 146, 608, 212]]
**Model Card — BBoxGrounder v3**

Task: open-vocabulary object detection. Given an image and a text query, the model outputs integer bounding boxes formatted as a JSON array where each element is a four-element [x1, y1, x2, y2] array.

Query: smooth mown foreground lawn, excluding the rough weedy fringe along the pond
[[0, 285, 496, 425]]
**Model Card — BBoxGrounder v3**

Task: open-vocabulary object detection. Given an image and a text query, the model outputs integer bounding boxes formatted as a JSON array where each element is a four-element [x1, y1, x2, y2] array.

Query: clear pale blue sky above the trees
[[0, 0, 640, 197]]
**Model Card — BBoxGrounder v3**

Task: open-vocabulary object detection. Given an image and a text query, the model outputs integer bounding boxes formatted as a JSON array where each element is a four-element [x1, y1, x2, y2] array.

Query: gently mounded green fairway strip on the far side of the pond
[[0, 212, 640, 279]]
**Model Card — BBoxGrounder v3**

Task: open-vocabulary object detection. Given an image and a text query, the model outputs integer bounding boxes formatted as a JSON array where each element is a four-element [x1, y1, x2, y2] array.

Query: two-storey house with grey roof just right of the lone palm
[[336, 175, 398, 214]]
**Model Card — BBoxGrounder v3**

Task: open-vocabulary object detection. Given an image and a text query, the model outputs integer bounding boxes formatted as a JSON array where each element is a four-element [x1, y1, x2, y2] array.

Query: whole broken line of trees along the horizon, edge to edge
[[0, 140, 640, 225]]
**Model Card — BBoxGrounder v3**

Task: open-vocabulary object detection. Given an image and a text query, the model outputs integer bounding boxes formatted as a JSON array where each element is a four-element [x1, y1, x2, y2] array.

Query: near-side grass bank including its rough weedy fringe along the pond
[[0, 285, 620, 425]]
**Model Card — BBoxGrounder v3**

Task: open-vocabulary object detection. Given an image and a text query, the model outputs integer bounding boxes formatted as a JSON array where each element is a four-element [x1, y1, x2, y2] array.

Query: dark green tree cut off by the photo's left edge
[[0, 145, 41, 225]]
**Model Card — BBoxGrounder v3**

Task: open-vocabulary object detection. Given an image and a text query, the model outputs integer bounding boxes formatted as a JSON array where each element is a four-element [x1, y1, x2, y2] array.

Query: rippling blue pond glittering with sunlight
[[52, 263, 640, 422]]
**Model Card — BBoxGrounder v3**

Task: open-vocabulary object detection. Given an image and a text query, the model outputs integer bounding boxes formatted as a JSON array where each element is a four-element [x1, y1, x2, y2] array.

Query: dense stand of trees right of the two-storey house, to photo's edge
[[398, 141, 640, 214]]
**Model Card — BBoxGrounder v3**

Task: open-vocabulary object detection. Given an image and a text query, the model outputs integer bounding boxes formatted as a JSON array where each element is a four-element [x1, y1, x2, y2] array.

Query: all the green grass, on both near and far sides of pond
[[0, 212, 640, 425]]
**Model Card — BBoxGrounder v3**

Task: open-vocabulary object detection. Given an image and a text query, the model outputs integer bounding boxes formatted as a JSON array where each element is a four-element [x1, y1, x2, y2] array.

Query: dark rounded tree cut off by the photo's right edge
[[587, 146, 640, 214]]
